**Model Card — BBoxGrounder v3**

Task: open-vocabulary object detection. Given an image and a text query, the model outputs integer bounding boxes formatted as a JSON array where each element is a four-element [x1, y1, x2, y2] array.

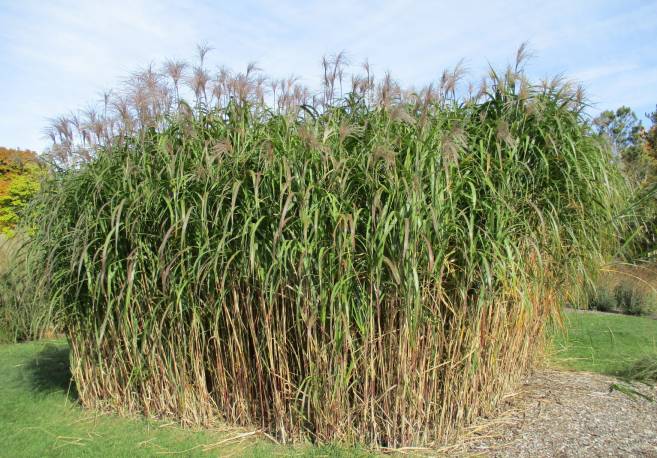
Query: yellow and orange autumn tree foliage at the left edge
[[0, 147, 43, 236]]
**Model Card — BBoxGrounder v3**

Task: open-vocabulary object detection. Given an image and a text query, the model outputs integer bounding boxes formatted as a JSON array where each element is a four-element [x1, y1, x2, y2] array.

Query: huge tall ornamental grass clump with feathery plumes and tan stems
[[32, 51, 623, 447]]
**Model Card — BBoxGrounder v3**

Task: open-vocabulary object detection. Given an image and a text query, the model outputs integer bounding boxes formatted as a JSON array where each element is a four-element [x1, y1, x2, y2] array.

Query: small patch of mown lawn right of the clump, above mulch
[[554, 311, 657, 379]]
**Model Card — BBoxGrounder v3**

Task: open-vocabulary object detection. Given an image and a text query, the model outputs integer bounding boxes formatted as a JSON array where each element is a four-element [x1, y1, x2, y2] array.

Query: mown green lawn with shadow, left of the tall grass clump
[[0, 341, 368, 457]]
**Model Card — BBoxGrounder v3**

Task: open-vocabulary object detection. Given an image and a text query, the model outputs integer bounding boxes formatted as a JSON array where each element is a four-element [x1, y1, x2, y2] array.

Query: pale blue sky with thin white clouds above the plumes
[[0, 0, 657, 151]]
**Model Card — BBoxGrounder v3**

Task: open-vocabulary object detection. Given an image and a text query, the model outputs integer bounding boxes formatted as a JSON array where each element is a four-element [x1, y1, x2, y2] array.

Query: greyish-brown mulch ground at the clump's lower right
[[462, 370, 657, 457]]
